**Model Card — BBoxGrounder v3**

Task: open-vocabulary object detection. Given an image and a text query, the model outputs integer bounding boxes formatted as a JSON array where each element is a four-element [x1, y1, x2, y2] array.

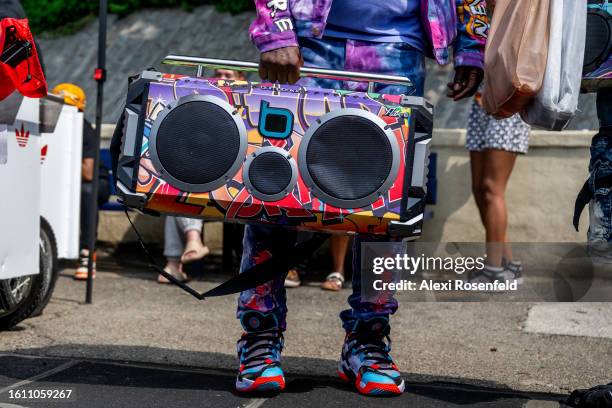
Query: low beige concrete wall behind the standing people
[[99, 125, 593, 249]]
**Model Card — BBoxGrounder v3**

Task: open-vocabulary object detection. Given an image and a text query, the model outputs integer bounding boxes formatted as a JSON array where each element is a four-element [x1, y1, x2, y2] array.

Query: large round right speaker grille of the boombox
[[306, 115, 393, 201]]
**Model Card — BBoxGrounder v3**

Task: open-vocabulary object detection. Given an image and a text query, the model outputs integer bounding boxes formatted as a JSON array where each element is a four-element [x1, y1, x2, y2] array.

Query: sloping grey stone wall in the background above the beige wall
[[39, 6, 597, 129]]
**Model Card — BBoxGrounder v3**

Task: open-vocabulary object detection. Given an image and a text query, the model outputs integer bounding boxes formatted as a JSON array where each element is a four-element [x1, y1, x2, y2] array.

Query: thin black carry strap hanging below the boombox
[[124, 207, 328, 300]]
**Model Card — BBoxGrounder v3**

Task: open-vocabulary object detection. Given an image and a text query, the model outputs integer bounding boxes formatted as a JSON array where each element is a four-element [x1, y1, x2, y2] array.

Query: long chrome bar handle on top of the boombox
[[162, 55, 413, 92]]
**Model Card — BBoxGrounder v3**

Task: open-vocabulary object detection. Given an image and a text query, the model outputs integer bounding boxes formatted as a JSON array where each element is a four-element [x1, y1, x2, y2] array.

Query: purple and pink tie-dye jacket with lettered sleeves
[[250, 0, 489, 68]]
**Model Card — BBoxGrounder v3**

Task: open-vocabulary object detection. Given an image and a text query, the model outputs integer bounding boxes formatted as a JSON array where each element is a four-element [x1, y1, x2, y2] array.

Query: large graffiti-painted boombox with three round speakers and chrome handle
[[113, 56, 433, 237]]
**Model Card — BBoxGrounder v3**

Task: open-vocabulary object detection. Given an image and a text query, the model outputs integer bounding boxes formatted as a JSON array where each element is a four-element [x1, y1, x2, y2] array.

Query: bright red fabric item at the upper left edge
[[0, 18, 47, 100]]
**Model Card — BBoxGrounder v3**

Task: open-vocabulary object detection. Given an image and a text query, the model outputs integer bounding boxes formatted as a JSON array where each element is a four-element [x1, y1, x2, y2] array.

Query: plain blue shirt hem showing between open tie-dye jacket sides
[[324, 0, 425, 51]]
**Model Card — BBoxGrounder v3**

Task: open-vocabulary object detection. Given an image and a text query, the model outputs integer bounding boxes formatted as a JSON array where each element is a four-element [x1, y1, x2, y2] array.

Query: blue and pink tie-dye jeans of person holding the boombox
[[237, 37, 425, 330]]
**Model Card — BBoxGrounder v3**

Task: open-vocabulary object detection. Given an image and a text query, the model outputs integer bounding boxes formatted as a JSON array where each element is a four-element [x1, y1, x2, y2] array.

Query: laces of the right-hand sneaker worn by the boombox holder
[[348, 333, 397, 370]]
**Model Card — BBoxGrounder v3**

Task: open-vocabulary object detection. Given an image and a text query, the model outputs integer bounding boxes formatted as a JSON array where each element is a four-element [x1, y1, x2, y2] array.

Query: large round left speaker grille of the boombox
[[155, 100, 241, 185]]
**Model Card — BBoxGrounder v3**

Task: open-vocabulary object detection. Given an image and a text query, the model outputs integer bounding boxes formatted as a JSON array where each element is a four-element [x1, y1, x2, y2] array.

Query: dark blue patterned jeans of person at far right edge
[[588, 88, 612, 261]]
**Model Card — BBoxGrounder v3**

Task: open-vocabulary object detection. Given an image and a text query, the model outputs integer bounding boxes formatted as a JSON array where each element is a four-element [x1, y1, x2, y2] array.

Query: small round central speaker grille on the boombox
[[248, 152, 292, 195]]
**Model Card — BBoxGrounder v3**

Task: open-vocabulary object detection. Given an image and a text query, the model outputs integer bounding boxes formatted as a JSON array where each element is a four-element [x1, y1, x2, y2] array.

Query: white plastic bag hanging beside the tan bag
[[521, 0, 587, 130]]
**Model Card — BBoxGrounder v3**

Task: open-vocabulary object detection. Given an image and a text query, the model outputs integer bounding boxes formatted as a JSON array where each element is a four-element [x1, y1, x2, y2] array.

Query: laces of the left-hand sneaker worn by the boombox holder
[[238, 328, 283, 371]]
